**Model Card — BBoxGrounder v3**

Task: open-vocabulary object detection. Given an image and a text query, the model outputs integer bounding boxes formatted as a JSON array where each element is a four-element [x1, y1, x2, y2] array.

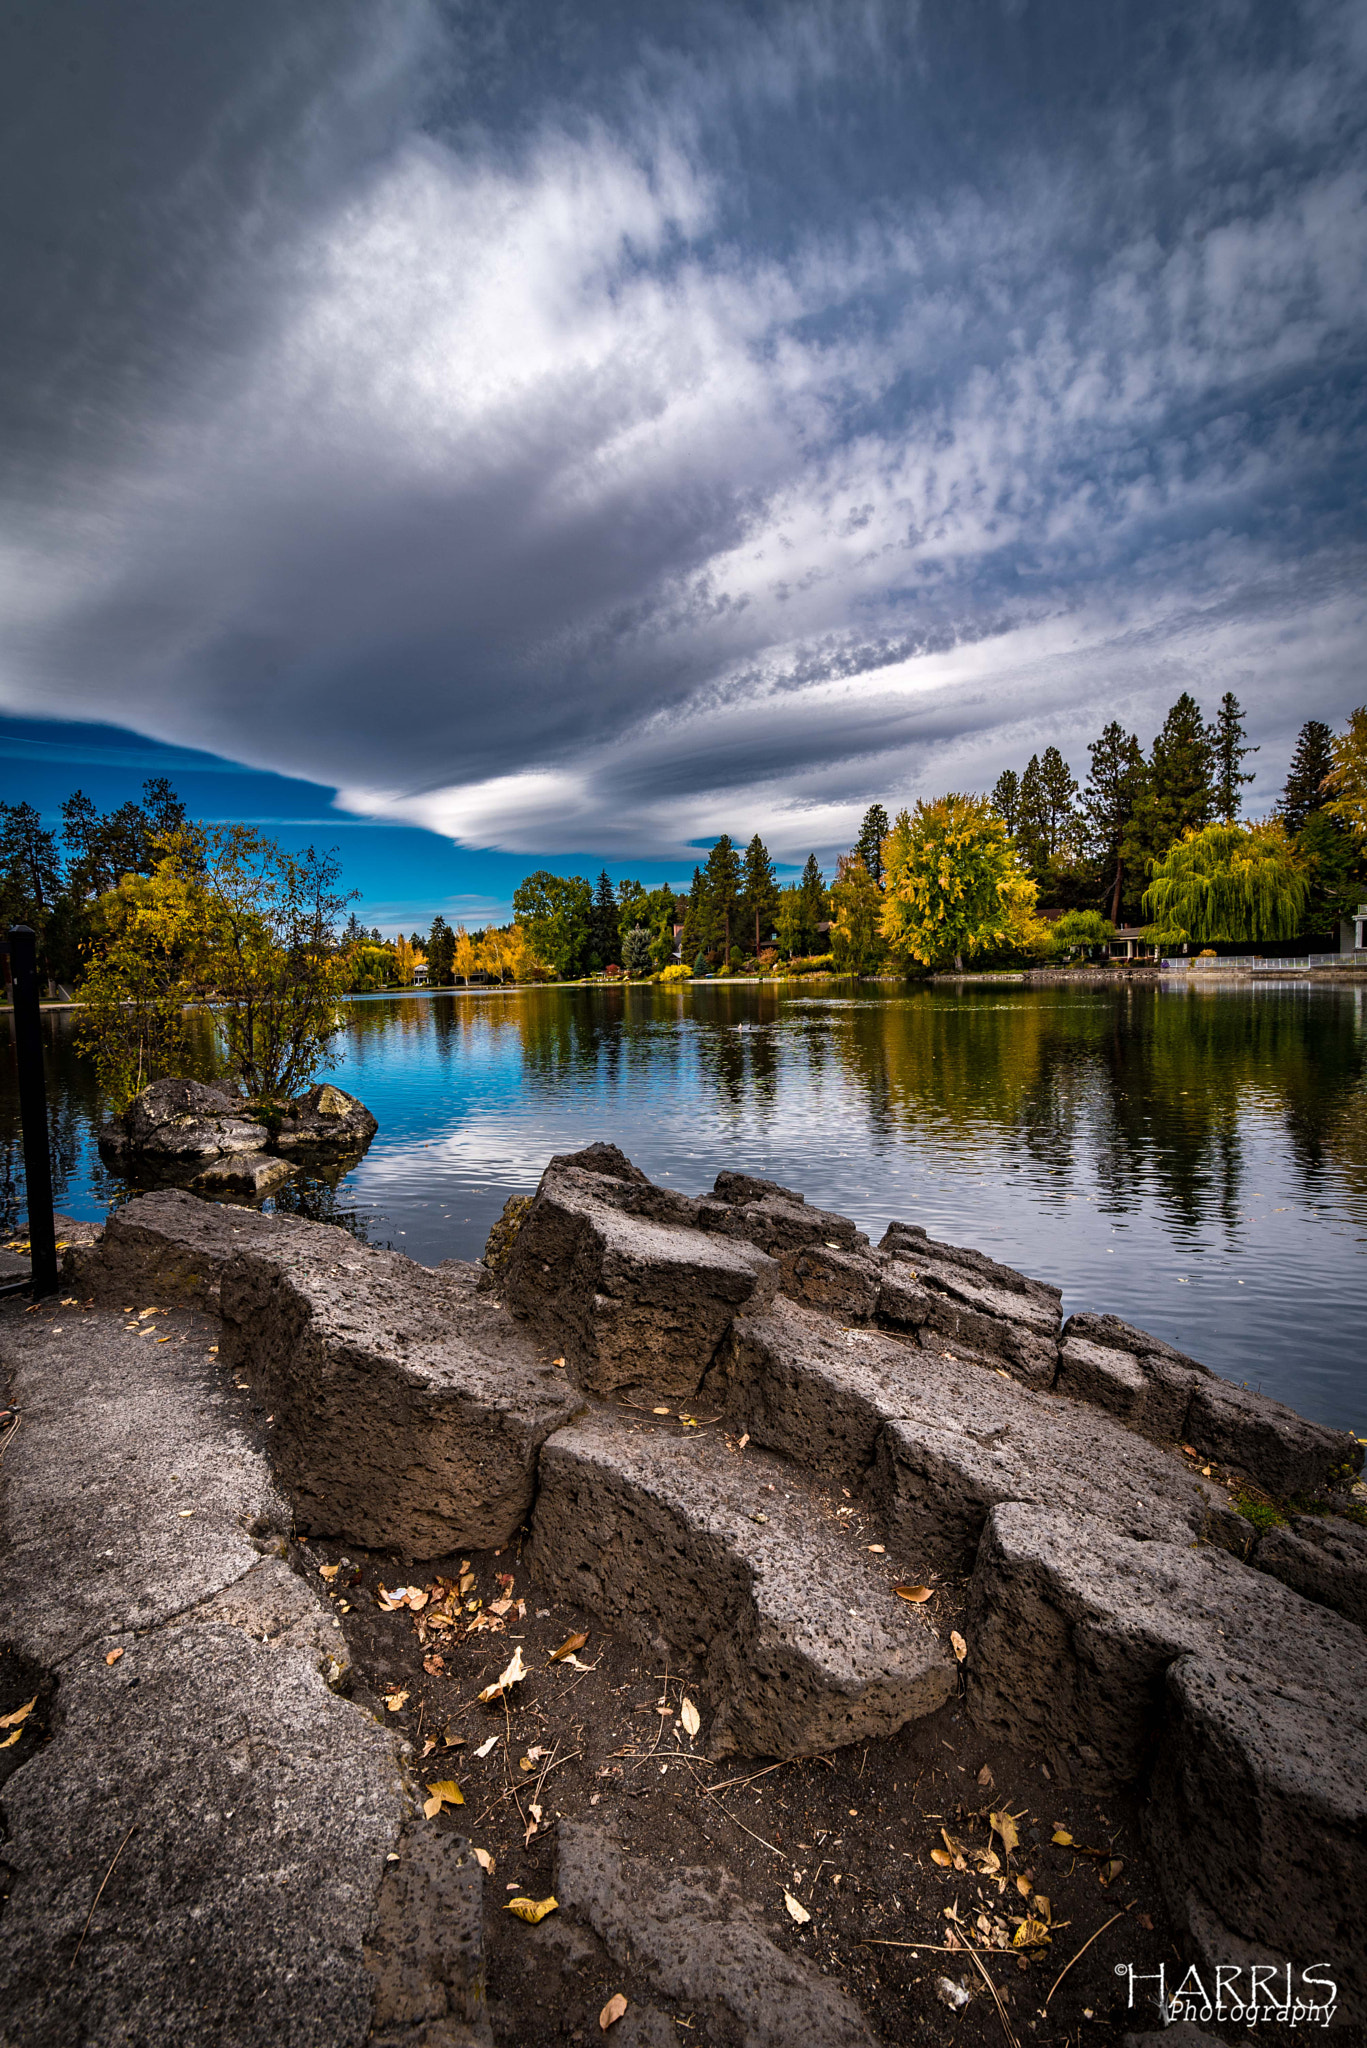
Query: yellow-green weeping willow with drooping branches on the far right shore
[[1144, 817, 1310, 946]]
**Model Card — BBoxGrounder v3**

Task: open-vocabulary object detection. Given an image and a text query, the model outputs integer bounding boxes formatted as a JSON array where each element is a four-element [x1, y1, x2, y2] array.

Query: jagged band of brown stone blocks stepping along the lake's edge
[[0, 1146, 1367, 2048]]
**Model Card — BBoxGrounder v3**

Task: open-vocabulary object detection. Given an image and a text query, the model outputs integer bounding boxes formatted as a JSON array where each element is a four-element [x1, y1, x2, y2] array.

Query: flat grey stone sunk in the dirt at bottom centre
[[555, 1821, 873, 2048]]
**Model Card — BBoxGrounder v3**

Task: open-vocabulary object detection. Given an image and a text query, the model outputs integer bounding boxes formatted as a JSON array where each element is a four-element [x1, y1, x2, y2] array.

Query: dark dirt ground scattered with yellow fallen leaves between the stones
[[297, 1433, 1178, 2048]]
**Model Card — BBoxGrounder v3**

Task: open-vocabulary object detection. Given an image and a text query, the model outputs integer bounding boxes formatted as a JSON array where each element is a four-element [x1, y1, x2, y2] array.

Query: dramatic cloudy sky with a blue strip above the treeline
[[0, 0, 1367, 926]]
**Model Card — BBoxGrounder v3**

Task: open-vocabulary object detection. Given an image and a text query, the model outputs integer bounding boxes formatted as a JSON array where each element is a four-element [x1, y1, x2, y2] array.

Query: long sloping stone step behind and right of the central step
[[705, 1300, 1252, 1569]]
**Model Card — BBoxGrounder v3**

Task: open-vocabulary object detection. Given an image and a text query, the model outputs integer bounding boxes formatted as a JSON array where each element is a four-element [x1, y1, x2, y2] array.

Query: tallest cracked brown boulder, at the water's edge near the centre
[[498, 1147, 779, 1397]]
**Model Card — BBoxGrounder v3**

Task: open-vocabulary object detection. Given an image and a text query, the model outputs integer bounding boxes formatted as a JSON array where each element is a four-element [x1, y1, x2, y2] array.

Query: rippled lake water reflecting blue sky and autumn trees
[[0, 983, 1367, 1432]]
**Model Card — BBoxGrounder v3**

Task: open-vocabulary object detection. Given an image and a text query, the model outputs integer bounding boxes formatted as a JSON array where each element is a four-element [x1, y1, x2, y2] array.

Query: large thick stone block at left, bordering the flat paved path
[[221, 1223, 580, 1559]]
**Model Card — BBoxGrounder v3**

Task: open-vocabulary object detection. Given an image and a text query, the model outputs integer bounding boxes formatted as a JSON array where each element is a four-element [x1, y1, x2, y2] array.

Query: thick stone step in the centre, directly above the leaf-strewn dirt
[[527, 1407, 955, 1757]]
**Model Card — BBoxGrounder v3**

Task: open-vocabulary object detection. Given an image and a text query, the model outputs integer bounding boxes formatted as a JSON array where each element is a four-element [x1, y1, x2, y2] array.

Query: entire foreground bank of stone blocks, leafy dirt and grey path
[[0, 1147, 1367, 2048]]
